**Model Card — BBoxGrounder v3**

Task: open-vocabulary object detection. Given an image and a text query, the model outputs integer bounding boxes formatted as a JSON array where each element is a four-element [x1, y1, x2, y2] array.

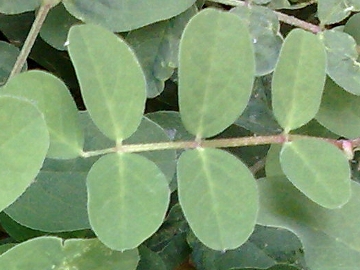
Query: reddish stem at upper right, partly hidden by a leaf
[[208, 0, 322, 34]]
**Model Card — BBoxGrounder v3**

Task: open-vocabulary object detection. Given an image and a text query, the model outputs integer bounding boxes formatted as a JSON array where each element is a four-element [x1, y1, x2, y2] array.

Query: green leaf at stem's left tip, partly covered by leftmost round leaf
[[0, 70, 84, 159]]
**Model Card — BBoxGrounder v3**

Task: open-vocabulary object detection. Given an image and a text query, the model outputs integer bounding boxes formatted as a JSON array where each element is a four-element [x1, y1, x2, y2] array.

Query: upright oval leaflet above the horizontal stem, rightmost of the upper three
[[272, 29, 326, 132]]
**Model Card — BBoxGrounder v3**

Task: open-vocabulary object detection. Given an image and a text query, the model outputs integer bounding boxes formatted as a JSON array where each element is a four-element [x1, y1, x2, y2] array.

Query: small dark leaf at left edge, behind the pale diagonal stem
[[0, 41, 27, 86]]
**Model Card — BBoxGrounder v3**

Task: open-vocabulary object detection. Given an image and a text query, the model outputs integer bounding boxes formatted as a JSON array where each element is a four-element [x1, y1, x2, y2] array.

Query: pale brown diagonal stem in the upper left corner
[[8, 2, 53, 79]]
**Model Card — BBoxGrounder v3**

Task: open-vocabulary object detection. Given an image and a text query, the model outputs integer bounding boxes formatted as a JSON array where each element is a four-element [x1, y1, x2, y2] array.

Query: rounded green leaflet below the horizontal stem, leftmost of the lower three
[[87, 154, 170, 251]]
